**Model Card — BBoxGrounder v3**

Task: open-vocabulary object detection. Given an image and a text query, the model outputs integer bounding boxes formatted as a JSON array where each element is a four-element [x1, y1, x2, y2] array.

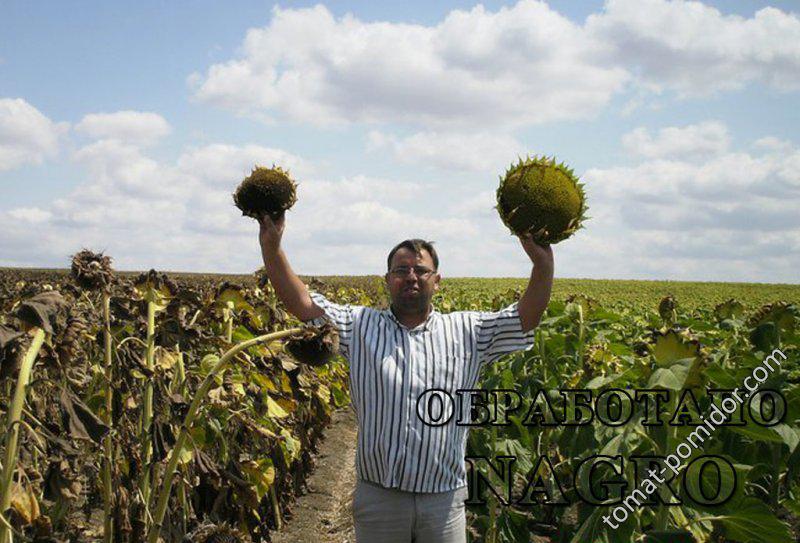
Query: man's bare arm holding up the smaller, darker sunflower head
[[258, 215, 325, 321]]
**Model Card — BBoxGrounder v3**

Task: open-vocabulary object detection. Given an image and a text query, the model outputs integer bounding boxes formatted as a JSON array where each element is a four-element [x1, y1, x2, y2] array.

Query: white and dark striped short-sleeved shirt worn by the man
[[310, 292, 534, 492]]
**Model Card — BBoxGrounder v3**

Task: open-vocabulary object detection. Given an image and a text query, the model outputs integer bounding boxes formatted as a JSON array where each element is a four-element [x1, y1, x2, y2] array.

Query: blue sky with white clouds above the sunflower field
[[0, 0, 800, 283]]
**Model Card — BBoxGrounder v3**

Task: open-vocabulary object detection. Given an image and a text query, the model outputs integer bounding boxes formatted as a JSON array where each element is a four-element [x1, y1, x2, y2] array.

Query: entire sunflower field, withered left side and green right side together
[[0, 260, 800, 543]]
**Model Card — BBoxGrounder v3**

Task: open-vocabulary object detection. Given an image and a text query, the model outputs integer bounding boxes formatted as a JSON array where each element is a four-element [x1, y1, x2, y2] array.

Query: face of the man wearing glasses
[[385, 247, 440, 313]]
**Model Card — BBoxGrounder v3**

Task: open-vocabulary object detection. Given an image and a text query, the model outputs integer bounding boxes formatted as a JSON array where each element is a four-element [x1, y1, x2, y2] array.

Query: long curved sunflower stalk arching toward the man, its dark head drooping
[[147, 328, 303, 543]]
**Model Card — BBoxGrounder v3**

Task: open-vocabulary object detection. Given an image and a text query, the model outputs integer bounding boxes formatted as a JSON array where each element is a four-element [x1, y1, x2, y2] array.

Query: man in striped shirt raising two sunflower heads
[[259, 215, 553, 543]]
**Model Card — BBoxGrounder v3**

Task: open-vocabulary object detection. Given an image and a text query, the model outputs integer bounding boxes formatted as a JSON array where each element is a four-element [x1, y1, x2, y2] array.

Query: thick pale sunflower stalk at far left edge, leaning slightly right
[[0, 328, 45, 543]]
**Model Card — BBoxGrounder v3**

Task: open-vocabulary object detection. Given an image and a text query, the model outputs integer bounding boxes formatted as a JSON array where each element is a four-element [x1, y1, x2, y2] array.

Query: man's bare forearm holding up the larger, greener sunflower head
[[517, 234, 554, 332]]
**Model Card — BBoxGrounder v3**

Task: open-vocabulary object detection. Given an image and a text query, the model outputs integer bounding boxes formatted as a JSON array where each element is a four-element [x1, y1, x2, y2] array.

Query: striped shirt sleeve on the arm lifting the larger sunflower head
[[476, 302, 535, 365]]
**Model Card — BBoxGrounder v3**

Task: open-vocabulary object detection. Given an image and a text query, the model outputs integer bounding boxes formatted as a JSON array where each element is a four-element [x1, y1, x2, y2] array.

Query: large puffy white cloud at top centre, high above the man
[[189, 0, 627, 126]]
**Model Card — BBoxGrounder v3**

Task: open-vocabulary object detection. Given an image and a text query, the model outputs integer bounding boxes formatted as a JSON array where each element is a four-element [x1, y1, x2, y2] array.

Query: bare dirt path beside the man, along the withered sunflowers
[[272, 406, 356, 543]]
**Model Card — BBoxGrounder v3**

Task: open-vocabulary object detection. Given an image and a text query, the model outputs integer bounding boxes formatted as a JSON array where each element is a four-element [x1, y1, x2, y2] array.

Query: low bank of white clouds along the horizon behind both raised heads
[[0, 127, 800, 281]]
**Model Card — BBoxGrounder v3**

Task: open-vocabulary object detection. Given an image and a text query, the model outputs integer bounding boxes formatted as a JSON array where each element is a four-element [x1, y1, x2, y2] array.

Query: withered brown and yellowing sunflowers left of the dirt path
[[0, 255, 354, 543]]
